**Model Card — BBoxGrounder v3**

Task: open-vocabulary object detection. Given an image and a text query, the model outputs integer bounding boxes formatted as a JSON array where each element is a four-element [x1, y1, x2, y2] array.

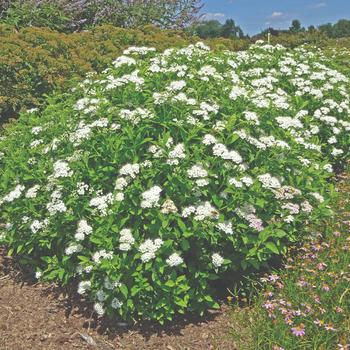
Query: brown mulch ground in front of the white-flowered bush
[[0, 249, 236, 350]]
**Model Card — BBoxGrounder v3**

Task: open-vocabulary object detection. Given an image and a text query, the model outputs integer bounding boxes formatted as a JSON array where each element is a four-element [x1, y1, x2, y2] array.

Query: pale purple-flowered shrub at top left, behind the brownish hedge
[[0, 0, 201, 32]]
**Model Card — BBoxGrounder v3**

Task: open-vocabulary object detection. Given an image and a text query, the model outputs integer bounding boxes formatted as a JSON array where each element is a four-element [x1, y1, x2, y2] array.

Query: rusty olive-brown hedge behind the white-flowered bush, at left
[[0, 25, 249, 122]]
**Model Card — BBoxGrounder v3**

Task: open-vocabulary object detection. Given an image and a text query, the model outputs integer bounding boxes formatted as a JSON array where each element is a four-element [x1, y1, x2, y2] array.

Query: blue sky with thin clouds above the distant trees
[[202, 0, 350, 34]]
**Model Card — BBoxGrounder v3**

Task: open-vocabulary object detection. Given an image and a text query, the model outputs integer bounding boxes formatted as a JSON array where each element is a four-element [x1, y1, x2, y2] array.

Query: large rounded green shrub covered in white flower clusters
[[0, 43, 350, 322]]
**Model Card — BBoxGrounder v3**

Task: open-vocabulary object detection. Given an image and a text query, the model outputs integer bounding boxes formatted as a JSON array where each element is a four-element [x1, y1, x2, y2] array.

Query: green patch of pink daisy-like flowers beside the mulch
[[232, 171, 350, 350]]
